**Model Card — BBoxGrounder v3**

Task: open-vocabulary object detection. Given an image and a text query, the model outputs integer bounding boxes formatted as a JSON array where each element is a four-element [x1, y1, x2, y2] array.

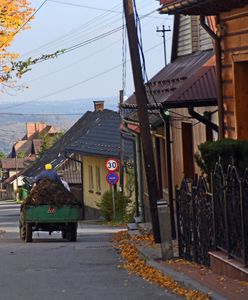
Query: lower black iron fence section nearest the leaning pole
[[176, 177, 214, 265]]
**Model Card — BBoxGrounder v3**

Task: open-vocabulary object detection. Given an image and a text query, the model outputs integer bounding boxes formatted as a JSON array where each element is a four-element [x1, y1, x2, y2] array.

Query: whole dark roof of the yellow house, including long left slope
[[24, 109, 132, 176]]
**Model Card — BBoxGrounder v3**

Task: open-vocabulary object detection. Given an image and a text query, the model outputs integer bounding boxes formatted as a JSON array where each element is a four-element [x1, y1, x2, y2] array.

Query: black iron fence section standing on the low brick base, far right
[[212, 163, 248, 267]]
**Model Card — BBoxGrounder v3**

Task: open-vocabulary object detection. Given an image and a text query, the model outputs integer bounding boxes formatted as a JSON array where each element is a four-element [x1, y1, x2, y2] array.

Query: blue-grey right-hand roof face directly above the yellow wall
[[66, 110, 132, 157]]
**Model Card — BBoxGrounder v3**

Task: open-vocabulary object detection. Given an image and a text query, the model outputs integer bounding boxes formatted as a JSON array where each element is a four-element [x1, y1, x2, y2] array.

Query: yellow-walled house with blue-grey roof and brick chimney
[[66, 102, 132, 218]]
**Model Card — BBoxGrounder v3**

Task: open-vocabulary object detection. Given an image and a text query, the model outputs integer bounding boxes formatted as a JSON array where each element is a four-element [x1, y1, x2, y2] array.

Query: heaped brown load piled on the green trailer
[[23, 178, 80, 207]]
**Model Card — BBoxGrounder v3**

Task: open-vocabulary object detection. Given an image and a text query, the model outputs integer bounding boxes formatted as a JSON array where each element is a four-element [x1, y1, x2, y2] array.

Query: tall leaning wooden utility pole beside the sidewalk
[[123, 0, 161, 243]]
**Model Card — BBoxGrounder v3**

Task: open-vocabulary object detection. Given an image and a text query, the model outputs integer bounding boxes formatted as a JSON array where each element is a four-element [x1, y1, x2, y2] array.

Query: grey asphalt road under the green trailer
[[0, 203, 178, 300]]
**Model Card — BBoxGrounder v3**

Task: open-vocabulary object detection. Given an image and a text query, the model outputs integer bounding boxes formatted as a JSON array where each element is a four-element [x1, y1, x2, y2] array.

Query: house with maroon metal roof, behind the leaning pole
[[122, 15, 219, 233]]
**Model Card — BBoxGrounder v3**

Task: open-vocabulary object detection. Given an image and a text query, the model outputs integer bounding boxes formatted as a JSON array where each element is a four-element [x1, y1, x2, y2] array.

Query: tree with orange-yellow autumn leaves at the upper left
[[0, 0, 34, 87]]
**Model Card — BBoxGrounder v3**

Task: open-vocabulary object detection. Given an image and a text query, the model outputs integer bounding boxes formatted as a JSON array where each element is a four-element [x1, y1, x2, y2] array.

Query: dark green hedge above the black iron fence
[[195, 139, 248, 176]]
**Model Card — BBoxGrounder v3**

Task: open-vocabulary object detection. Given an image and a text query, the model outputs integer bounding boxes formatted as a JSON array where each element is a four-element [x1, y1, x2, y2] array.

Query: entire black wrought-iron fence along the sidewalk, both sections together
[[176, 163, 248, 267]]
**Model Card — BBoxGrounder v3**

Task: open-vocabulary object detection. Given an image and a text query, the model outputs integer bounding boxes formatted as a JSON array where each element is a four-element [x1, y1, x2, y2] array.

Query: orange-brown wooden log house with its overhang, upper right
[[160, 0, 248, 140]]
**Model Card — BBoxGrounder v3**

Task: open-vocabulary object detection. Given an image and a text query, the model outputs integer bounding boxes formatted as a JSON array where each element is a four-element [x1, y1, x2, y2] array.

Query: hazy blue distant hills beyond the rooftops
[[0, 97, 118, 154]]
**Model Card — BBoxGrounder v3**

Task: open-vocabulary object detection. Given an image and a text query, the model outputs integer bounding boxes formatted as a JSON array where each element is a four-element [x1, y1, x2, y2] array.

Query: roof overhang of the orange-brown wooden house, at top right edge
[[159, 0, 248, 16]]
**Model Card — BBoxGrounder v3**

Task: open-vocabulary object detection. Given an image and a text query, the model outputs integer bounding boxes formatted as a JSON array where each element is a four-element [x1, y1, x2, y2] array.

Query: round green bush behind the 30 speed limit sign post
[[98, 191, 131, 222]]
